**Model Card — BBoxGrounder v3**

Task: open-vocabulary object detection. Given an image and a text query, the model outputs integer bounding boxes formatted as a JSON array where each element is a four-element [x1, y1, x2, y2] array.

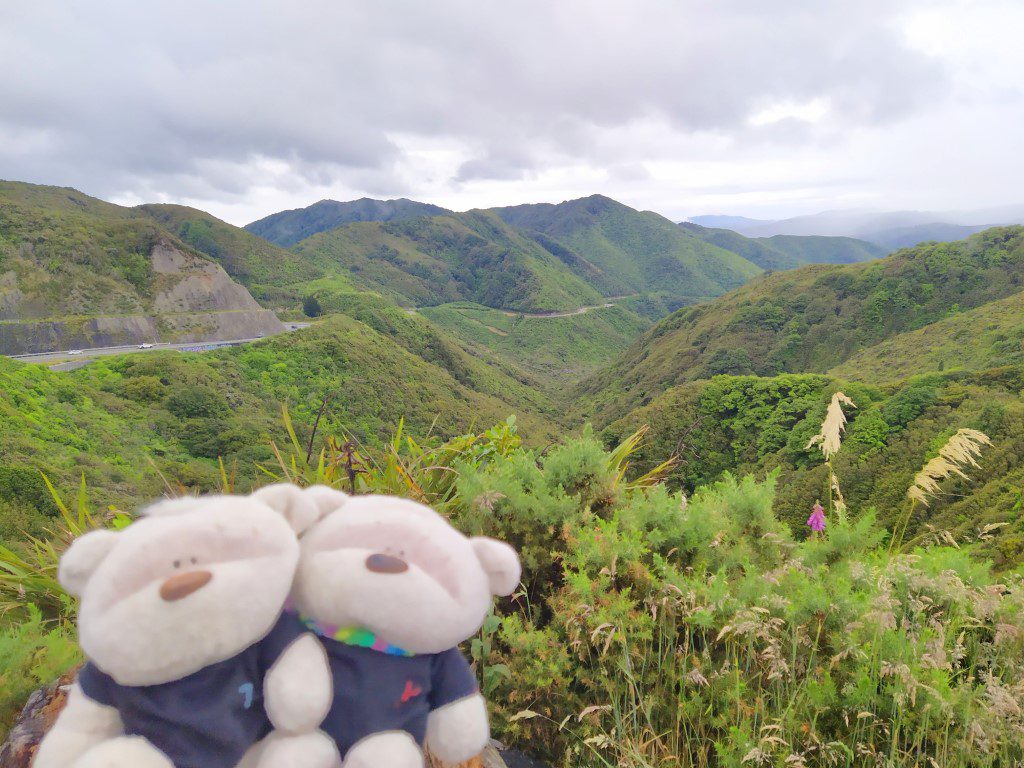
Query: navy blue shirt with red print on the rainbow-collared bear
[[321, 637, 477, 758]]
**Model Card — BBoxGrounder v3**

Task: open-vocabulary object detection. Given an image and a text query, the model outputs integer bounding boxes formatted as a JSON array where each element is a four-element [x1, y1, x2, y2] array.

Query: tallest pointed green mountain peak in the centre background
[[492, 195, 761, 306]]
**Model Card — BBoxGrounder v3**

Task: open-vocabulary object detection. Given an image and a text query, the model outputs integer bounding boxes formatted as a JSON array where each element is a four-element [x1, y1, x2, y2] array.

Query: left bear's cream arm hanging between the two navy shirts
[[263, 632, 334, 734]]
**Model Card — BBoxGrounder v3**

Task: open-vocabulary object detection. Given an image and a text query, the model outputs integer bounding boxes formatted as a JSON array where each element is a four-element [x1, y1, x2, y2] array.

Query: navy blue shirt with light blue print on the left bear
[[78, 613, 307, 768]]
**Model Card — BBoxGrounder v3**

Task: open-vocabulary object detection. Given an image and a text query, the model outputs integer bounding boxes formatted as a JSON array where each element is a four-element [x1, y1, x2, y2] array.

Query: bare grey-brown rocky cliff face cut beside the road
[[0, 240, 285, 354]]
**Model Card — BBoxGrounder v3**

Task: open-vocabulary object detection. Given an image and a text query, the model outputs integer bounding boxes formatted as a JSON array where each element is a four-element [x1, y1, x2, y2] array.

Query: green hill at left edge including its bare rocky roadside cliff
[[0, 181, 284, 354]]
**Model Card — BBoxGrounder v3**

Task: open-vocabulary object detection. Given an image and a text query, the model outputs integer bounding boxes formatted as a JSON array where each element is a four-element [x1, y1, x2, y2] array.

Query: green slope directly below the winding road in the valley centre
[[420, 303, 649, 382]]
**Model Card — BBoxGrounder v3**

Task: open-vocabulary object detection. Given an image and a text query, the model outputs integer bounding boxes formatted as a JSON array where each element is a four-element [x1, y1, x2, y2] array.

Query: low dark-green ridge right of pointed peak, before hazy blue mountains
[[679, 221, 889, 271]]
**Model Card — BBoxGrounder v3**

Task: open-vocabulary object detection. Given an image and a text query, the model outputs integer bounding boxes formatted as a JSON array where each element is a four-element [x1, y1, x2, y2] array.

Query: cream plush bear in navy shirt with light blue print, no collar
[[34, 486, 338, 768]]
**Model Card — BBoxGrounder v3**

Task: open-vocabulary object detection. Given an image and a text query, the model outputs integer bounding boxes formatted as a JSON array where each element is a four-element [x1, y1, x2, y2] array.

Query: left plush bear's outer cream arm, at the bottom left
[[32, 683, 124, 768]]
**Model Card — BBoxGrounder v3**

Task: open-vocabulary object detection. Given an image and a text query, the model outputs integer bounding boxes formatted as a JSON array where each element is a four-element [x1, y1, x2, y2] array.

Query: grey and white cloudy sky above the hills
[[0, 0, 1024, 224]]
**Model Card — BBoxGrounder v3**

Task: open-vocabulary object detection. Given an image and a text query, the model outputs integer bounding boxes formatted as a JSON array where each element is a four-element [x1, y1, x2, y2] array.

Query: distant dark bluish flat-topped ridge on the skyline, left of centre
[[246, 198, 451, 248]]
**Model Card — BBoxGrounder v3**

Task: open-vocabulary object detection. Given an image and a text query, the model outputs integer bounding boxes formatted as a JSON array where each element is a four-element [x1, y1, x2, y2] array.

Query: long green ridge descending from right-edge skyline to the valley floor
[[580, 227, 1024, 424]]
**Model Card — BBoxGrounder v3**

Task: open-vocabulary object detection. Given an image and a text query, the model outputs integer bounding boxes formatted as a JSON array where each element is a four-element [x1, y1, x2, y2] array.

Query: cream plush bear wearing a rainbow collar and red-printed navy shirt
[[293, 490, 520, 768]]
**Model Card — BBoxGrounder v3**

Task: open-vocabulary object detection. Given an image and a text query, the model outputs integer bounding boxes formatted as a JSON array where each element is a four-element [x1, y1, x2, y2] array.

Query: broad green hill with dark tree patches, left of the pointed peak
[[293, 212, 600, 311]]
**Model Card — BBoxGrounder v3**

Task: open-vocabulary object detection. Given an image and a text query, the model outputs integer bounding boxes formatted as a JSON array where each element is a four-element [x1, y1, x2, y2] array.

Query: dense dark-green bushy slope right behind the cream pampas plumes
[[604, 367, 1024, 566]]
